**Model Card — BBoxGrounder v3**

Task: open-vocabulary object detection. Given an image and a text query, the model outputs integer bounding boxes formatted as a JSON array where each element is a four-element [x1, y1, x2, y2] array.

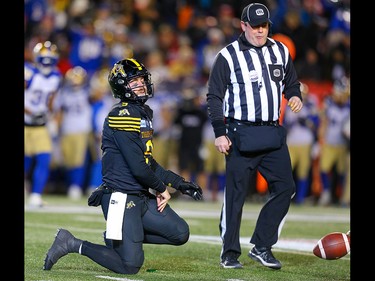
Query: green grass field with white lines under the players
[[24, 195, 351, 281]]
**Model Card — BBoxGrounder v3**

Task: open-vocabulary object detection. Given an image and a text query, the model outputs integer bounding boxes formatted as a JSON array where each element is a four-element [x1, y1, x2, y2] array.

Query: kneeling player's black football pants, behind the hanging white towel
[[81, 193, 189, 274]]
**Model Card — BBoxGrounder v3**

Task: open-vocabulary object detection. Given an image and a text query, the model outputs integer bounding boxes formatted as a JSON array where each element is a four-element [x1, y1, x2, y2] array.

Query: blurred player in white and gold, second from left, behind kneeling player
[[56, 66, 92, 200]]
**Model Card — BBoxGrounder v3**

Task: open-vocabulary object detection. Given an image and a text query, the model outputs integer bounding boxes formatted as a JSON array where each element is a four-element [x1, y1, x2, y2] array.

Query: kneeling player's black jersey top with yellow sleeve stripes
[[101, 101, 183, 194]]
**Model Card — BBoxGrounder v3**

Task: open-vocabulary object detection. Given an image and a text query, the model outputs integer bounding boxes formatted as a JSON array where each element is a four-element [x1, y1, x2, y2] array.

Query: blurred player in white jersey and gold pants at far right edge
[[318, 77, 350, 206]]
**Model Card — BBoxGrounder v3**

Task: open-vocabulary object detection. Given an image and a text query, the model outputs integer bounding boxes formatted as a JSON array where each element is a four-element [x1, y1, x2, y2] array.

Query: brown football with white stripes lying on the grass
[[313, 232, 350, 260]]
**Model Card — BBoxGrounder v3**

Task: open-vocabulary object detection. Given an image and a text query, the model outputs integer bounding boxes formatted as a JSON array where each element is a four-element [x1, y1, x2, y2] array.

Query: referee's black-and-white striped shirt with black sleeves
[[207, 33, 302, 137]]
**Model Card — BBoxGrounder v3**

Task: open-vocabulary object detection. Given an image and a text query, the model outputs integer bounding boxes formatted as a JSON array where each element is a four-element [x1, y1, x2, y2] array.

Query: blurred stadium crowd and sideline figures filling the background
[[24, 0, 350, 207]]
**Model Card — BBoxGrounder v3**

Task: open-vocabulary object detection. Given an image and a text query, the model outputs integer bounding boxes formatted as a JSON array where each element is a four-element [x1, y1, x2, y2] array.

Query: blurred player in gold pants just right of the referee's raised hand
[[284, 83, 319, 204]]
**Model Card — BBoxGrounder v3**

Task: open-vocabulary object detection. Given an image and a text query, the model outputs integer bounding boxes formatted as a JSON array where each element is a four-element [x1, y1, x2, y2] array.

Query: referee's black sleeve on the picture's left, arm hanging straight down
[[207, 54, 230, 138]]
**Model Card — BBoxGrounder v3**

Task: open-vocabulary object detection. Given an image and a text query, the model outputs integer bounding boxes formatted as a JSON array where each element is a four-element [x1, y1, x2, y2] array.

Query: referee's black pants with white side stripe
[[219, 124, 296, 259]]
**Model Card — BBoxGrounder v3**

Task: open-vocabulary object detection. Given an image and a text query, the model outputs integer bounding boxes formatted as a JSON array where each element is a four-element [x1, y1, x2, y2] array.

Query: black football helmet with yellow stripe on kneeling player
[[108, 58, 154, 103]]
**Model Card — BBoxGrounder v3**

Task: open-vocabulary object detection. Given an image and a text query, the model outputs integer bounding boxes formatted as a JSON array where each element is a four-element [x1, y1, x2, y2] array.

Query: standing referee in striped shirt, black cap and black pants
[[207, 3, 303, 269]]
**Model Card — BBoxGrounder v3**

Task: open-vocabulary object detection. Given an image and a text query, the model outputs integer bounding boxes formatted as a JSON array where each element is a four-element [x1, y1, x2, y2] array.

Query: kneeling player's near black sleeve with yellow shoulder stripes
[[109, 109, 166, 192]]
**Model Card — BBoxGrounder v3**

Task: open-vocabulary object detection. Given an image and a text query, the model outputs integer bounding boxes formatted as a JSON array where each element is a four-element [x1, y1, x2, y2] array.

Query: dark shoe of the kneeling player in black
[[43, 228, 82, 270]]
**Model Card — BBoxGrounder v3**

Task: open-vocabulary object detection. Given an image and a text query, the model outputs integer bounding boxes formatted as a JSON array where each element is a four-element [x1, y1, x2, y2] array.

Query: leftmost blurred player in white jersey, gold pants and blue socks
[[24, 41, 62, 207]]
